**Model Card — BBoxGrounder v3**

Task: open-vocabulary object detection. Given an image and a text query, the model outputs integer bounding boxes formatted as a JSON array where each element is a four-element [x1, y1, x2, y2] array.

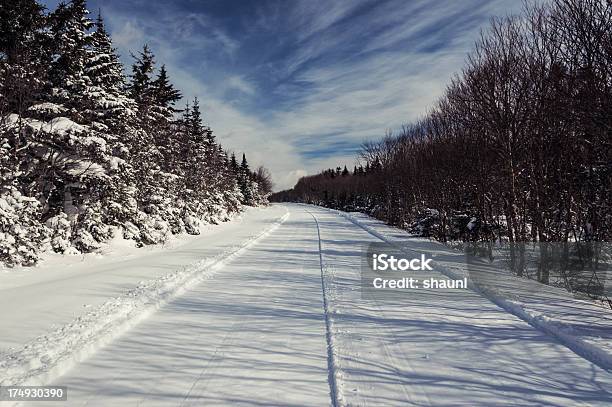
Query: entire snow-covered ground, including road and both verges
[[0, 204, 612, 406]]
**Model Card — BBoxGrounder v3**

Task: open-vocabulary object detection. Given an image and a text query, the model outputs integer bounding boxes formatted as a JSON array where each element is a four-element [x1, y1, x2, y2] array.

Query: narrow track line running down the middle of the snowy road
[[306, 209, 347, 407]]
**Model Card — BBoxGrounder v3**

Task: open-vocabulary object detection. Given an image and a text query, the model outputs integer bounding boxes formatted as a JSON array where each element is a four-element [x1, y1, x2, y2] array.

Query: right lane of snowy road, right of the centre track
[[310, 208, 612, 406]]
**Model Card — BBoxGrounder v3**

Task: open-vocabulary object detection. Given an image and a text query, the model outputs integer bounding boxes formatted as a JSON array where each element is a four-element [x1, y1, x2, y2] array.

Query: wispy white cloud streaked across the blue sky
[[98, 0, 518, 189]]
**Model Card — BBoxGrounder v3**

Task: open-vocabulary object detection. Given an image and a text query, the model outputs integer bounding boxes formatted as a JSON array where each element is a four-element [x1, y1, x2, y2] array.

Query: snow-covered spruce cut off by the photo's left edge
[[0, 0, 49, 266]]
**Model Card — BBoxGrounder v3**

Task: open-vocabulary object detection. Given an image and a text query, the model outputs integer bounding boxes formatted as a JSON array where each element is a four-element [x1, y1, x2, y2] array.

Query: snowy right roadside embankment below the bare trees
[[328, 209, 612, 371]]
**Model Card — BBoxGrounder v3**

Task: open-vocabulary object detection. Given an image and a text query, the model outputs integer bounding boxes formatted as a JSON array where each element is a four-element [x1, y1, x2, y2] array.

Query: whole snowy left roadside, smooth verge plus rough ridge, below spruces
[[0, 209, 284, 384]]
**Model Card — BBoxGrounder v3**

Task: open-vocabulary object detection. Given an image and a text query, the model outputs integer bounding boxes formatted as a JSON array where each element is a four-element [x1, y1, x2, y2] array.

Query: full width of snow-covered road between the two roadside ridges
[[5, 205, 612, 406]]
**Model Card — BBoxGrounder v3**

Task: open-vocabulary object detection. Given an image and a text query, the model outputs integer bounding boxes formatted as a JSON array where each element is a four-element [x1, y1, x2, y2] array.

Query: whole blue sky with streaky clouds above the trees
[[43, 0, 521, 189]]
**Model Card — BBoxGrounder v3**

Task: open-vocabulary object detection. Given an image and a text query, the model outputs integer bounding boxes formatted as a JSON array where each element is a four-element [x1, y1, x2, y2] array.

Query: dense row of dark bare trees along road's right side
[[272, 0, 612, 242]]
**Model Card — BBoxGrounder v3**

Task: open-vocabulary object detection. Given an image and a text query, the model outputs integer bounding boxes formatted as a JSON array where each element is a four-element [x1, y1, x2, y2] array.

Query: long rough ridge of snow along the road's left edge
[[0, 207, 289, 385]]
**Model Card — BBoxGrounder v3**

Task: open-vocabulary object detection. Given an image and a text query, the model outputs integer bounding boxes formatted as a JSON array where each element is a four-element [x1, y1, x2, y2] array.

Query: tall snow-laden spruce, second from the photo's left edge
[[27, 0, 134, 252]]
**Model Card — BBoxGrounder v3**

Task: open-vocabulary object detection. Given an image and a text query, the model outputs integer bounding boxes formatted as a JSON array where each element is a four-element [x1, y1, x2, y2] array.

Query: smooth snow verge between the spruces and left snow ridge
[[0, 207, 285, 353]]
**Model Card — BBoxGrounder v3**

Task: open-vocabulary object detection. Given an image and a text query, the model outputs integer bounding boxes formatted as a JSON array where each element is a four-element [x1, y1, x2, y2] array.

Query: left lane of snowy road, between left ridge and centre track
[[29, 206, 329, 406]]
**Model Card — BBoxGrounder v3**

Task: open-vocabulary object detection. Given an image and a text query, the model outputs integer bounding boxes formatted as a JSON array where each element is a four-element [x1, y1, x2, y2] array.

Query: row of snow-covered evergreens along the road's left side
[[0, 0, 272, 266]]
